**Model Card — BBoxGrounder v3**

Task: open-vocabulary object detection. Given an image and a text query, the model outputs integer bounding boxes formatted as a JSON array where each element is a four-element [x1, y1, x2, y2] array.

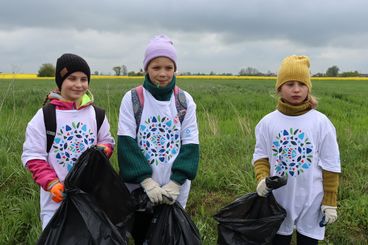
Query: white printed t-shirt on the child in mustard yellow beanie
[[253, 110, 341, 240]]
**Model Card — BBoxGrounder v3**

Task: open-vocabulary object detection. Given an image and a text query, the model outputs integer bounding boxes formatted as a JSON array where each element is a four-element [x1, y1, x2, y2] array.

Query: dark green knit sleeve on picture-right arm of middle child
[[171, 144, 199, 185]]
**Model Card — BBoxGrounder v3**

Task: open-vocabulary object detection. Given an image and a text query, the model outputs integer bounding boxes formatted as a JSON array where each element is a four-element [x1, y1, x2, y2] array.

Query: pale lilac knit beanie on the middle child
[[143, 35, 176, 71]]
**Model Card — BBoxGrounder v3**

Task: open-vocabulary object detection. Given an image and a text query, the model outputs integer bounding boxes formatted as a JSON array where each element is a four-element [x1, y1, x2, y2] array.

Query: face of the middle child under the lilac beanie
[[147, 57, 175, 87]]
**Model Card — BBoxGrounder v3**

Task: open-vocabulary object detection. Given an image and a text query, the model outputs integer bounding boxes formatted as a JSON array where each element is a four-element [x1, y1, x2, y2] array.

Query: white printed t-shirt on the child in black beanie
[[22, 106, 115, 228]]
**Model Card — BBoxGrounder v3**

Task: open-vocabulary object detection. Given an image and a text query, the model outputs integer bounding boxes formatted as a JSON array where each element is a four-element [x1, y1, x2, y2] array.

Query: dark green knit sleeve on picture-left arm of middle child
[[118, 136, 152, 184]]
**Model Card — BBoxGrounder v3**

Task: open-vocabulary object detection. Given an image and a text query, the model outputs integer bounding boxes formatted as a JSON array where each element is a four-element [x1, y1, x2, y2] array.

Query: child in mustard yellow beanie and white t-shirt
[[253, 55, 341, 245]]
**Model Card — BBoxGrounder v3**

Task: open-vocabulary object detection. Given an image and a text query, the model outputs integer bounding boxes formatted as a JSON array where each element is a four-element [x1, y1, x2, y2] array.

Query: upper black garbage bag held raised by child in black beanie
[[65, 147, 136, 226]]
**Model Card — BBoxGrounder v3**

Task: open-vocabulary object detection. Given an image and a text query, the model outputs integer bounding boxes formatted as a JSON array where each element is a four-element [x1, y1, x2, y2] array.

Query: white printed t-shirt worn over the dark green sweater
[[118, 89, 199, 207]]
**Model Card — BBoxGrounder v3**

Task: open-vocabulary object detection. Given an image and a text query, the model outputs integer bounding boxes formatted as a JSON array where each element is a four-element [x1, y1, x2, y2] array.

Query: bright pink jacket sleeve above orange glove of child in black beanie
[[26, 159, 58, 191]]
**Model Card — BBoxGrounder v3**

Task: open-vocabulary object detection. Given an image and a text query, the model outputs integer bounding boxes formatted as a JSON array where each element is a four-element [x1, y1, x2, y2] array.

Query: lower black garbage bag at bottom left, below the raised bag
[[37, 189, 127, 245]]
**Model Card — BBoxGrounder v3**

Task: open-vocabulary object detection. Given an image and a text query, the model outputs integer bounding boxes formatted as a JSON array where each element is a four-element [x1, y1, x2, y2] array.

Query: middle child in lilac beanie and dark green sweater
[[118, 35, 199, 244]]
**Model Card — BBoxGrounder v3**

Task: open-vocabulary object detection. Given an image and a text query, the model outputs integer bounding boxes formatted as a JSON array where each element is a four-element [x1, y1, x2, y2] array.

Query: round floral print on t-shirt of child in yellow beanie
[[272, 128, 313, 176]]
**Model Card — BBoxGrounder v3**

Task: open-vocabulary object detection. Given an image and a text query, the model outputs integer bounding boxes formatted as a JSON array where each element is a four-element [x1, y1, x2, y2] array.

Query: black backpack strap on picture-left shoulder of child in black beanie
[[42, 103, 56, 153]]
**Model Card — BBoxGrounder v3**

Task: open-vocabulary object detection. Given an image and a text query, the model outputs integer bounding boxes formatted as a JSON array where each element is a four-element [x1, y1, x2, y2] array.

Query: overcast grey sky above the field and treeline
[[0, 0, 368, 74]]
